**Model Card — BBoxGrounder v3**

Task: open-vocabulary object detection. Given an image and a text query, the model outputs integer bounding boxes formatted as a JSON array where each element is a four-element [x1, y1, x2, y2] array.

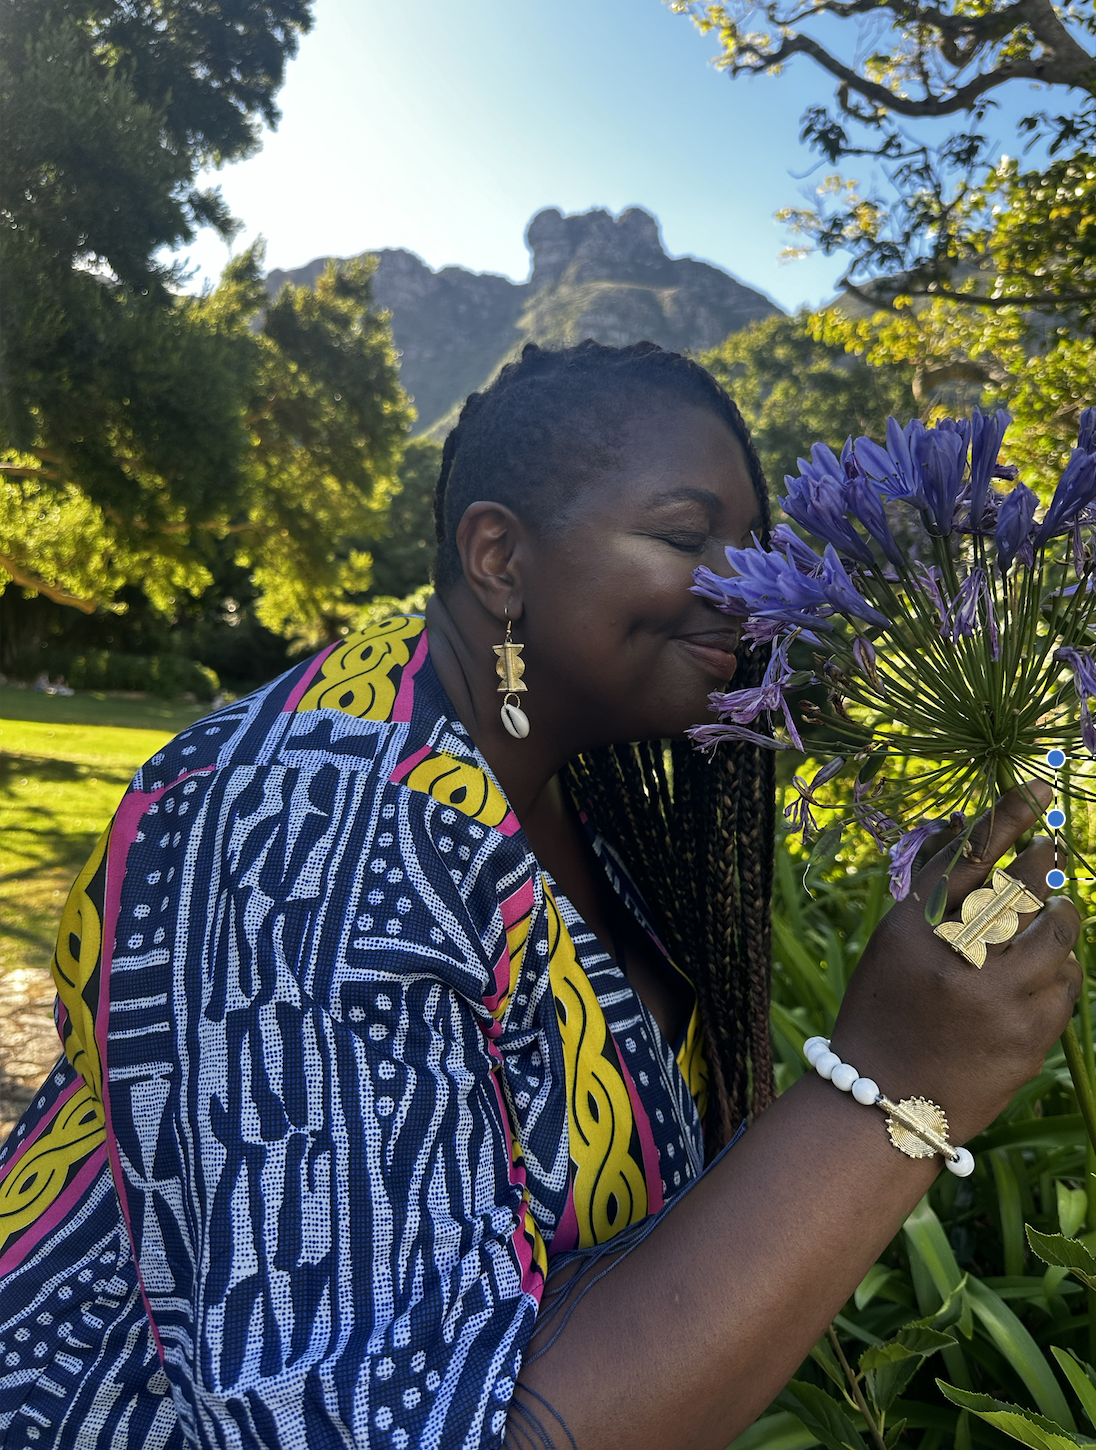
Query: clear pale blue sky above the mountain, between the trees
[[175, 0, 1032, 309]]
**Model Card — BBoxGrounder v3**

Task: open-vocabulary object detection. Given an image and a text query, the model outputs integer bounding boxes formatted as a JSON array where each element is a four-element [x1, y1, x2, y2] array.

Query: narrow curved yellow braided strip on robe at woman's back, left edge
[[49, 822, 113, 1101]]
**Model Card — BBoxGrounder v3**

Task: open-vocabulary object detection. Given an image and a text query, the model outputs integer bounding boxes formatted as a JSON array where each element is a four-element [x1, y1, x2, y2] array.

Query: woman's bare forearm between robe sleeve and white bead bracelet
[[510, 1073, 939, 1450]]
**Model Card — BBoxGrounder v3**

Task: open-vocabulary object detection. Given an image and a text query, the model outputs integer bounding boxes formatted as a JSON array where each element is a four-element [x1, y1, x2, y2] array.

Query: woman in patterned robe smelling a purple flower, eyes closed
[[0, 344, 1080, 1450]]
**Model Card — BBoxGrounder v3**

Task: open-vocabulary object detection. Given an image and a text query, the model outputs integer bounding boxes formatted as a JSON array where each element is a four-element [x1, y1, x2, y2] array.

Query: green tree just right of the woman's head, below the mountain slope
[[702, 312, 918, 483]]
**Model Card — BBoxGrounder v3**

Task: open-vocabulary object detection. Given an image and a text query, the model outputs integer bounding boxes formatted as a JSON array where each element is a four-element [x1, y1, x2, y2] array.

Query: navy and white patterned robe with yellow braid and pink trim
[[0, 616, 705, 1450]]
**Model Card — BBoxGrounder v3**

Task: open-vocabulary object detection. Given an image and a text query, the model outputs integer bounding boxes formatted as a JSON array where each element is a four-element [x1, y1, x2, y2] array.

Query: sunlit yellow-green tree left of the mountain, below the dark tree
[[0, 249, 412, 644]]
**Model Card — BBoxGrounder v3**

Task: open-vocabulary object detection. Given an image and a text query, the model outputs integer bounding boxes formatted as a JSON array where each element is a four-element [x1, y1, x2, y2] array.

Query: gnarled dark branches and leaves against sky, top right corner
[[674, 0, 1096, 316]]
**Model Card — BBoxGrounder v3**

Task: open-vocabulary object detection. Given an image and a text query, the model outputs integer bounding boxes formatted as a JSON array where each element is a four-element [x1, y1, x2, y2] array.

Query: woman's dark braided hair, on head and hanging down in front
[[435, 341, 776, 1151]]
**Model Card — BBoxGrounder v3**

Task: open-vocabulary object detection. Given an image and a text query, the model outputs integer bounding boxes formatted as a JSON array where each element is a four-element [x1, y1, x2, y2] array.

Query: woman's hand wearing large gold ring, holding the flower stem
[[832, 782, 1082, 1143]]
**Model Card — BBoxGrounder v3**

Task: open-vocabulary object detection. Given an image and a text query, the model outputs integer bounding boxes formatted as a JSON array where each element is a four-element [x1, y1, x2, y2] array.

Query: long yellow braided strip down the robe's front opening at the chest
[[545, 887, 648, 1248]]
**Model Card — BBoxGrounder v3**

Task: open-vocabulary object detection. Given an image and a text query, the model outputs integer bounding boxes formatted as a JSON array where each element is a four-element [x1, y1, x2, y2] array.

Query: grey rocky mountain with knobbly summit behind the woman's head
[[267, 206, 779, 436]]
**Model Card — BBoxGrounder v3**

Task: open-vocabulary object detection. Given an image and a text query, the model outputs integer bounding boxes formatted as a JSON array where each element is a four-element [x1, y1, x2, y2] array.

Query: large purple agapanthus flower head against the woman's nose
[[692, 407, 1096, 899]]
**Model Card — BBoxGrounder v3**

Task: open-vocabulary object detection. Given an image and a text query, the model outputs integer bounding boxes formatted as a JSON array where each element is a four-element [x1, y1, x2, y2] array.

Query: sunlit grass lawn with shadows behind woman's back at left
[[0, 689, 209, 1137]]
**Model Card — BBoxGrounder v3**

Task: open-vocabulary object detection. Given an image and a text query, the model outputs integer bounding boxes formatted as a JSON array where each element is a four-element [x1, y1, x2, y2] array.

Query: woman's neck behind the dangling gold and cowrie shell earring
[[426, 589, 583, 828]]
